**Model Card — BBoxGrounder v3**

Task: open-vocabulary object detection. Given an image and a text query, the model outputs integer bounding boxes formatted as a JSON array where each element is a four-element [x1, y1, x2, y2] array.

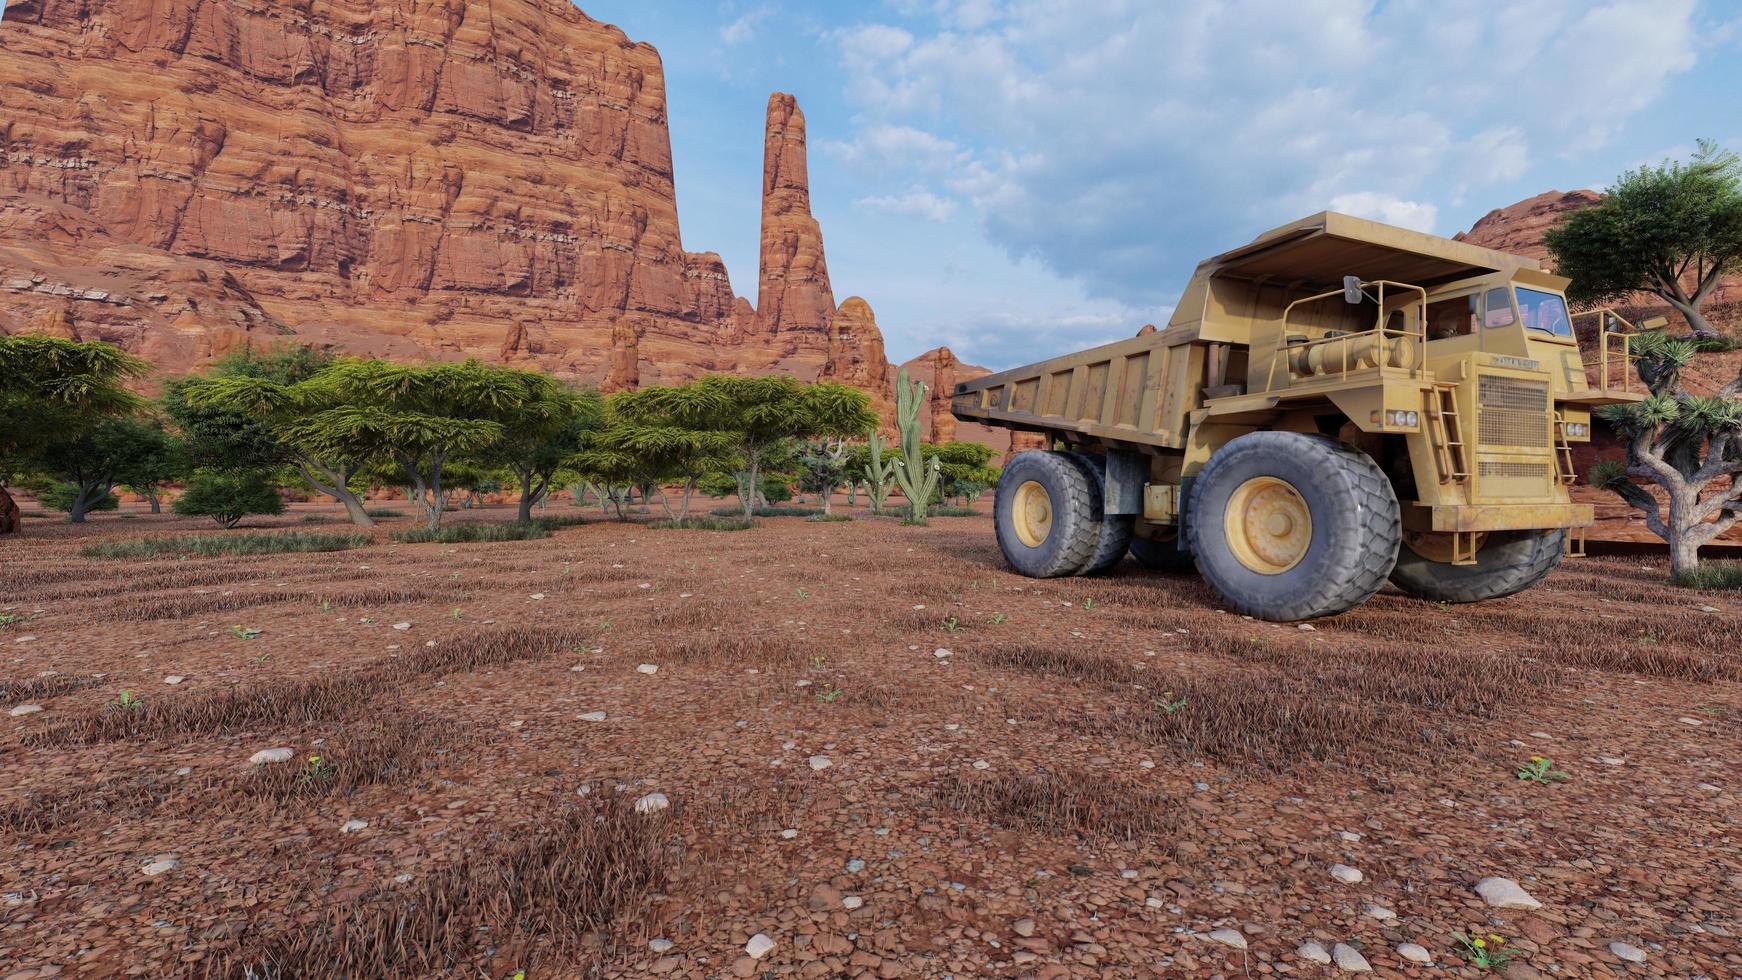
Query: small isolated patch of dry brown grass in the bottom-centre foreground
[[934, 771, 1183, 839]]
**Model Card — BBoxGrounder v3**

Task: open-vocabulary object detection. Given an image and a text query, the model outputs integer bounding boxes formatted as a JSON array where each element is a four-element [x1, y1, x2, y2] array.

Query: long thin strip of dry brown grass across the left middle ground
[[24, 627, 587, 747]]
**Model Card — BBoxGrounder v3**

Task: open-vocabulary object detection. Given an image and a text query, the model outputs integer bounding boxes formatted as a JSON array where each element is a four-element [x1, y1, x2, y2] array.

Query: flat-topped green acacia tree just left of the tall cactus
[[620, 374, 878, 517]]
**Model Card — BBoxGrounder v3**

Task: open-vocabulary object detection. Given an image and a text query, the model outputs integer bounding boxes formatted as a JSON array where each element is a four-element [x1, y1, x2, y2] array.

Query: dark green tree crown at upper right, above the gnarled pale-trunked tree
[[1543, 139, 1742, 336]]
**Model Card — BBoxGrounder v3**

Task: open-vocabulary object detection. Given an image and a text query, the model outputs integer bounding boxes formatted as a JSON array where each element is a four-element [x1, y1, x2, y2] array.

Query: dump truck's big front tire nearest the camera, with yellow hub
[[1186, 432, 1402, 621]]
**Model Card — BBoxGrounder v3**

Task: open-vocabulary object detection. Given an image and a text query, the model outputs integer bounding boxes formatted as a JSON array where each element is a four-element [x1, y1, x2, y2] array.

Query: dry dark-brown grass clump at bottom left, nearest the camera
[[226, 802, 672, 980]]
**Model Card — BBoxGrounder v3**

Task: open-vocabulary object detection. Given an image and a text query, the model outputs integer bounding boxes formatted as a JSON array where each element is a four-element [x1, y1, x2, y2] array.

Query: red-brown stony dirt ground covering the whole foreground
[[0, 507, 1742, 978]]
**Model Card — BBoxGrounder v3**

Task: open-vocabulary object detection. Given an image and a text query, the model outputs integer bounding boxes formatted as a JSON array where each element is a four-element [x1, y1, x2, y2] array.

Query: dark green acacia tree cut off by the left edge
[[0, 336, 146, 534]]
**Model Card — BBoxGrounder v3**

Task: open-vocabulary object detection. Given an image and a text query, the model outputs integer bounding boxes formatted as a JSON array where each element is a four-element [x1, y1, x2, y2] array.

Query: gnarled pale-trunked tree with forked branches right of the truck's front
[[1589, 332, 1742, 580]]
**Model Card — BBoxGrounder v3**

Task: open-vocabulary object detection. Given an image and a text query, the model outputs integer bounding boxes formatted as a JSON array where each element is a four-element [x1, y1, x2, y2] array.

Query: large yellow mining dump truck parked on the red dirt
[[951, 212, 1643, 620]]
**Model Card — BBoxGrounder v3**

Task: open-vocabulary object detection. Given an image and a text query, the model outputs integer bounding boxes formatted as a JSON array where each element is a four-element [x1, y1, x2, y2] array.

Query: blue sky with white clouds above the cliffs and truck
[[580, 0, 1742, 367]]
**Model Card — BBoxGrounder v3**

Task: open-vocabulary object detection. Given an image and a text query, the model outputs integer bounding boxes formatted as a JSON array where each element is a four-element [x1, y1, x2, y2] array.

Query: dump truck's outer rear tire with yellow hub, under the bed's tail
[[993, 449, 1101, 578]]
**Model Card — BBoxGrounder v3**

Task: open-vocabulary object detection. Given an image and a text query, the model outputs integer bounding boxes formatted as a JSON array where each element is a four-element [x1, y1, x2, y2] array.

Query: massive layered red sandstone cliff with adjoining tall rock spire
[[0, 0, 881, 396]]
